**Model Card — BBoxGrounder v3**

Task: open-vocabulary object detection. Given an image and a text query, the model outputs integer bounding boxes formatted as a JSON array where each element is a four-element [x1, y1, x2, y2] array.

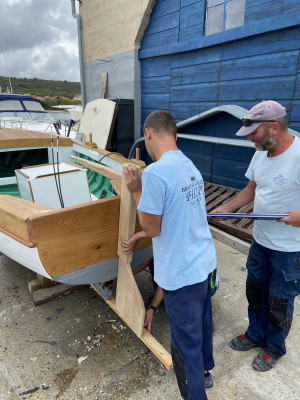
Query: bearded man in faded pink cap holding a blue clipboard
[[213, 100, 300, 371]]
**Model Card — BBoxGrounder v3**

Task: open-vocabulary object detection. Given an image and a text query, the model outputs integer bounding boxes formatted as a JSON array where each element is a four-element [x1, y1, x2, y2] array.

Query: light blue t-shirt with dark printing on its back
[[138, 150, 216, 290]]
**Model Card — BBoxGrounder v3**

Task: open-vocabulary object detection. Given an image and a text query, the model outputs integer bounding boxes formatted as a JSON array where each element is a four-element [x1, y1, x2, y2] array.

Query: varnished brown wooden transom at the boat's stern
[[28, 196, 120, 276]]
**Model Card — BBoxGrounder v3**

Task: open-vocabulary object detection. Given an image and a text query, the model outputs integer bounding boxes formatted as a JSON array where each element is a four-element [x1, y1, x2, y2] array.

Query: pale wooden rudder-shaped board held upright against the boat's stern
[[116, 168, 145, 337]]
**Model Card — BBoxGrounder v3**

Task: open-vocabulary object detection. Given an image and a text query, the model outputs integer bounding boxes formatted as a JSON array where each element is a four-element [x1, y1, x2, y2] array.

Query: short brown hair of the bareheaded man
[[144, 110, 177, 138]]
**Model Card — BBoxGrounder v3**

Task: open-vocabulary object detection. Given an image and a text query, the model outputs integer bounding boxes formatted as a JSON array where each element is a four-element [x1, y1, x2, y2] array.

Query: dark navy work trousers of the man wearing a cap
[[246, 240, 300, 358]]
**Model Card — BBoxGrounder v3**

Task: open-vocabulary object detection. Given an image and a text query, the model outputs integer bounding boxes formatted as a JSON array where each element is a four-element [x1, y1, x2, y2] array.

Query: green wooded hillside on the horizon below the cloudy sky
[[0, 76, 81, 99]]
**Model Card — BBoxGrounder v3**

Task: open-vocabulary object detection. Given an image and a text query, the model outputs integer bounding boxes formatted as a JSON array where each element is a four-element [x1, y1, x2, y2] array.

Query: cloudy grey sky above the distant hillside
[[0, 0, 80, 82]]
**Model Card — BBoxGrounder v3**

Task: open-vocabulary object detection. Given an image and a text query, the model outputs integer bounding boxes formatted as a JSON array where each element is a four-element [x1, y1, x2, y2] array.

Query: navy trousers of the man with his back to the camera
[[163, 275, 215, 400]]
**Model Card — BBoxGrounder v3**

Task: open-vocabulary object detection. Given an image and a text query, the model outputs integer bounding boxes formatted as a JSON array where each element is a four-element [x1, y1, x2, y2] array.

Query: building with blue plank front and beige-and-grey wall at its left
[[78, 0, 300, 188]]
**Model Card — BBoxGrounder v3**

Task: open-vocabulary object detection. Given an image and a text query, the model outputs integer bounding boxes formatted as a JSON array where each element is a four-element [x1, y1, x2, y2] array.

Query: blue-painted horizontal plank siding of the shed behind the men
[[141, 0, 300, 188]]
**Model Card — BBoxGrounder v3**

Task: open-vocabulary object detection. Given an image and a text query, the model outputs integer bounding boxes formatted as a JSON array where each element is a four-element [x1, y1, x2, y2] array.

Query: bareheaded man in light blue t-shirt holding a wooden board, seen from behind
[[124, 111, 216, 400]]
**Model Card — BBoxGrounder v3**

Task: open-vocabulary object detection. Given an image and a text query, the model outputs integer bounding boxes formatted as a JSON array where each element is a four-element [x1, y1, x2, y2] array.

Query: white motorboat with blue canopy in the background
[[0, 93, 79, 137]]
